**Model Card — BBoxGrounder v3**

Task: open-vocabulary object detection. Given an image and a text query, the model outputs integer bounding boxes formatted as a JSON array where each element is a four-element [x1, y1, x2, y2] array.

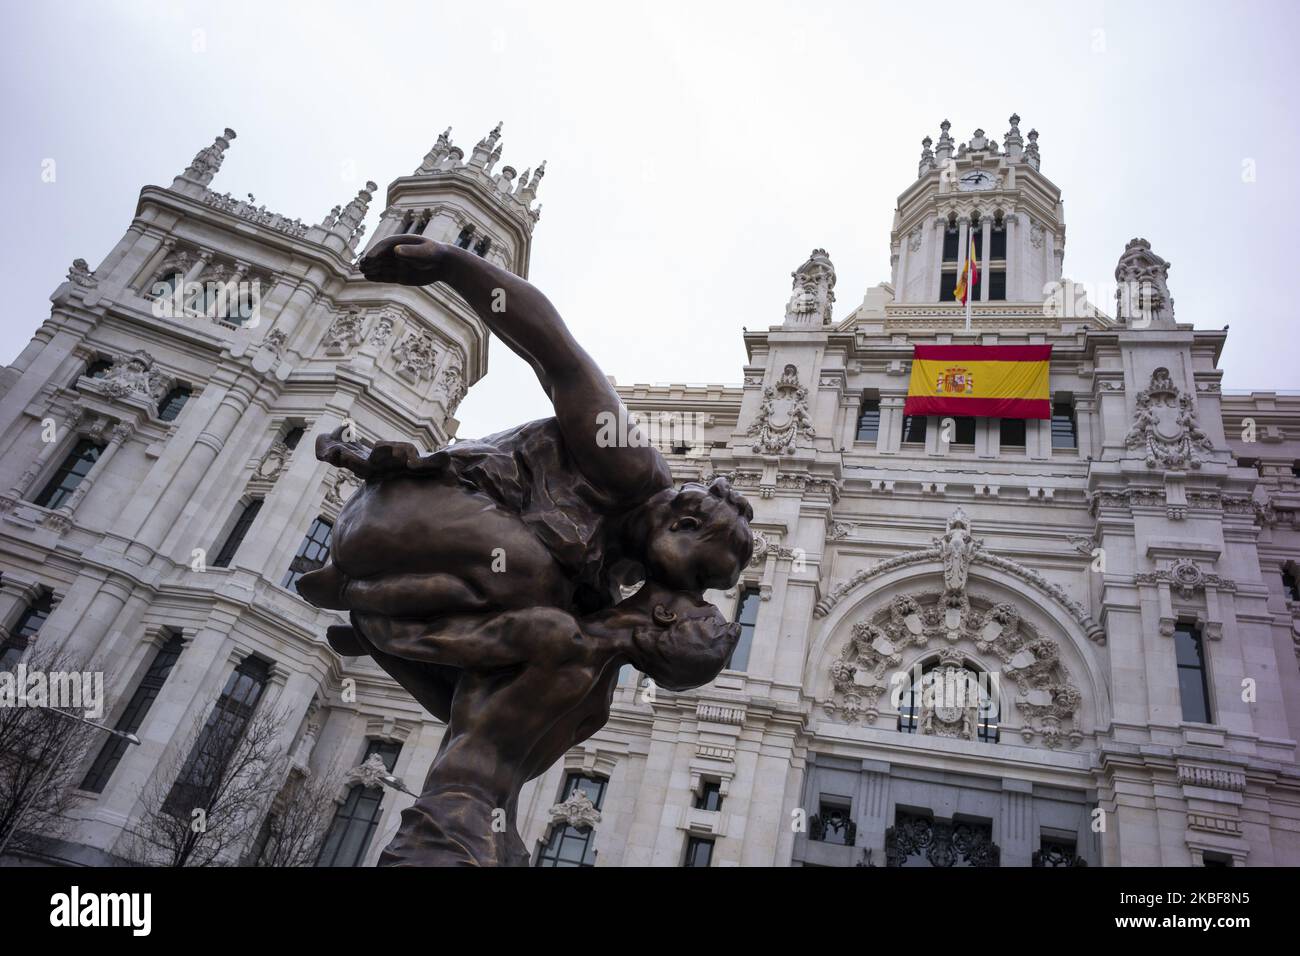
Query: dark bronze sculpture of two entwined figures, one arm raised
[[298, 235, 753, 866]]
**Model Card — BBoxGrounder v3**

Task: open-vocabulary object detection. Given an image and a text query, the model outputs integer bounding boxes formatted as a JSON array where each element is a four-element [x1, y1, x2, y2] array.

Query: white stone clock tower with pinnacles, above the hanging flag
[[891, 114, 1065, 307]]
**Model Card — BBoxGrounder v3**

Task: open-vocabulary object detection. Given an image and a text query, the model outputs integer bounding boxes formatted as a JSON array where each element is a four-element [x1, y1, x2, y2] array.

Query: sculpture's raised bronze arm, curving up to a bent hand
[[361, 235, 672, 501]]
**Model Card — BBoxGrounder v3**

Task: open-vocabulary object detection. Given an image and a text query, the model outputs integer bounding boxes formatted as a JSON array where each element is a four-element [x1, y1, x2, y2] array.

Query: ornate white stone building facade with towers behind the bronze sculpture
[[0, 116, 1300, 866]]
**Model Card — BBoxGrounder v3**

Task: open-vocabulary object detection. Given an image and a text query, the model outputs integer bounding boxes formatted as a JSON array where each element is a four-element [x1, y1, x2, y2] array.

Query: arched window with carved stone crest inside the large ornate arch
[[898, 659, 1000, 744]]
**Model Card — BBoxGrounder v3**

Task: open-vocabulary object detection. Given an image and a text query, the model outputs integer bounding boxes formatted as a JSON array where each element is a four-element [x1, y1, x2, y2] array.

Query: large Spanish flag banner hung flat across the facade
[[902, 345, 1052, 419]]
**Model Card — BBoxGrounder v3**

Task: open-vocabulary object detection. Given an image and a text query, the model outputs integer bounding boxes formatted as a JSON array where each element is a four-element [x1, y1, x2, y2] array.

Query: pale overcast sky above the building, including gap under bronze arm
[[0, 0, 1300, 437]]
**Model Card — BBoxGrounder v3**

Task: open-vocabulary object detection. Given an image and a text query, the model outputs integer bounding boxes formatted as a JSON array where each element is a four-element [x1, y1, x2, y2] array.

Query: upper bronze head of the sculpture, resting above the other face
[[627, 477, 754, 593]]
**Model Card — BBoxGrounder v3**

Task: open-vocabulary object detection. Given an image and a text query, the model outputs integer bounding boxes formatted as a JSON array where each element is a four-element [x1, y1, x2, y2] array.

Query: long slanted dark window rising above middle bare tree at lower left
[[163, 657, 270, 817]]
